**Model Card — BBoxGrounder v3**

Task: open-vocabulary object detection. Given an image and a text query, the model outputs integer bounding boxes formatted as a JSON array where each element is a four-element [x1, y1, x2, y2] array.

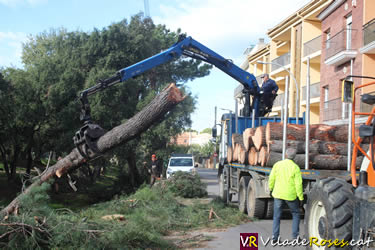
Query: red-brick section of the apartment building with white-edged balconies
[[319, 0, 364, 124]]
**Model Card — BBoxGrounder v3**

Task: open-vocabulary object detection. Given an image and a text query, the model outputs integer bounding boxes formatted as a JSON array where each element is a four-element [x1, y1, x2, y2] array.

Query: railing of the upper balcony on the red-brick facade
[[325, 29, 357, 60]]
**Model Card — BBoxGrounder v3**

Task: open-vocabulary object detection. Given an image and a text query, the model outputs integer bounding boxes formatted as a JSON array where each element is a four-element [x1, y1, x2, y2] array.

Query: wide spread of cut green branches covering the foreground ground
[[0, 183, 253, 249]]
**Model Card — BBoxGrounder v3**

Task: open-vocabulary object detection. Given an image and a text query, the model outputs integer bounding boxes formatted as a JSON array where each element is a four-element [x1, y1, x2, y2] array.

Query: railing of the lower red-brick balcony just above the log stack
[[323, 98, 349, 121]]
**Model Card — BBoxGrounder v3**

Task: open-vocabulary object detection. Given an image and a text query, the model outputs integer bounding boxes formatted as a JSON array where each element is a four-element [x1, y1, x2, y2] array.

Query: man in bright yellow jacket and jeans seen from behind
[[268, 148, 303, 242]]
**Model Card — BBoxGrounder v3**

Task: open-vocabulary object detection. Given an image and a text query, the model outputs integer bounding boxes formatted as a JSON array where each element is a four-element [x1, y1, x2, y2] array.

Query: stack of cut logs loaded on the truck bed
[[227, 122, 369, 170]]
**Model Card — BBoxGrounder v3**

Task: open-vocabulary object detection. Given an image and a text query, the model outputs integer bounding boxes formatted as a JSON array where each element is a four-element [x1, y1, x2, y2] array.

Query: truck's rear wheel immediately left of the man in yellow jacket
[[246, 179, 266, 219]]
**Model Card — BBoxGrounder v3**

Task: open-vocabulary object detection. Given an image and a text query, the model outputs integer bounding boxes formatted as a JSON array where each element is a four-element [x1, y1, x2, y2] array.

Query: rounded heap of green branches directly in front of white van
[[167, 171, 207, 198]]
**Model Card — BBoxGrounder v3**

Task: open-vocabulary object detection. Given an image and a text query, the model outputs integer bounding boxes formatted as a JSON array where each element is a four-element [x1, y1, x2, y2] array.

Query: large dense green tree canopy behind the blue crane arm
[[0, 15, 212, 186]]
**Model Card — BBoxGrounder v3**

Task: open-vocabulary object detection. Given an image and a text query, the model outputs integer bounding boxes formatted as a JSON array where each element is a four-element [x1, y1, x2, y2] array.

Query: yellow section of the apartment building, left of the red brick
[[243, 0, 332, 123]]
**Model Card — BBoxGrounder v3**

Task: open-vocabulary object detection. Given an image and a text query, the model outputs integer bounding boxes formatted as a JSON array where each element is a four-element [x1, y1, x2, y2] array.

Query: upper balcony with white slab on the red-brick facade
[[325, 29, 357, 66]]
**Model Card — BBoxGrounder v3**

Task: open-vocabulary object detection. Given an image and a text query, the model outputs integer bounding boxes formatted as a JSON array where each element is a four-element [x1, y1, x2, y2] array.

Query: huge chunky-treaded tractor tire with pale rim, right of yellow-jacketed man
[[305, 177, 354, 249]]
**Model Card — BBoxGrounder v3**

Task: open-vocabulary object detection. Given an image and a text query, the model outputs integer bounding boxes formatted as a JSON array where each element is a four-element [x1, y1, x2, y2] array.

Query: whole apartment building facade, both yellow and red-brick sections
[[242, 0, 375, 124]]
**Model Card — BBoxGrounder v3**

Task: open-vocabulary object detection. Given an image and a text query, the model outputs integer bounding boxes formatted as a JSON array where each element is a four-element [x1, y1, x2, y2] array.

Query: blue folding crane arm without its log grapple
[[80, 37, 260, 122]]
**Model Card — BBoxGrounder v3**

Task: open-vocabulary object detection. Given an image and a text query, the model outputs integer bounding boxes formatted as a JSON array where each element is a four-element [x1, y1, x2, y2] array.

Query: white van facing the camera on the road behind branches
[[167, 154, 195, 178]]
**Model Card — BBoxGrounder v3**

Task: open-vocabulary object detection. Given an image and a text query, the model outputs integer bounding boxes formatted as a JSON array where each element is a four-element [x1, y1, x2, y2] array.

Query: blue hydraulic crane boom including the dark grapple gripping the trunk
[[74, 36, 265, 159]]
